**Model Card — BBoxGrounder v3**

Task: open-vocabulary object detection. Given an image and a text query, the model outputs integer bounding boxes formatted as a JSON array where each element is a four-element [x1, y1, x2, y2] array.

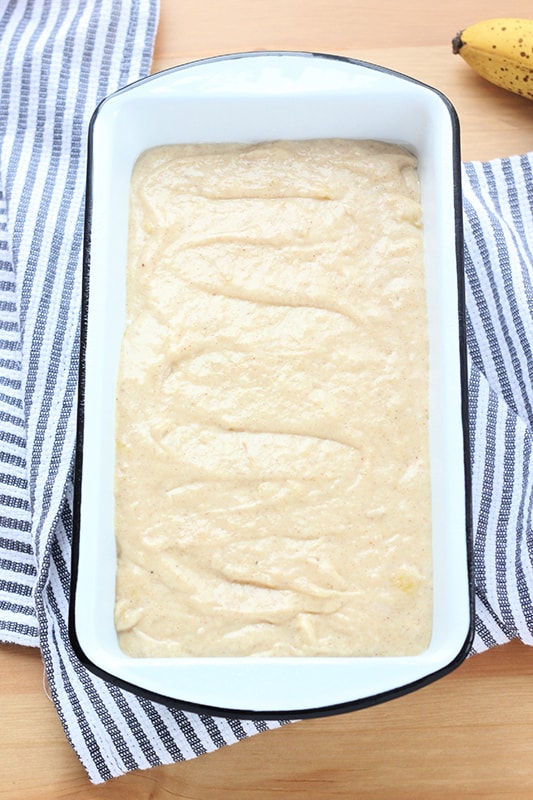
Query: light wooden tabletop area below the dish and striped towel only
[[0, 642, 533, 800]]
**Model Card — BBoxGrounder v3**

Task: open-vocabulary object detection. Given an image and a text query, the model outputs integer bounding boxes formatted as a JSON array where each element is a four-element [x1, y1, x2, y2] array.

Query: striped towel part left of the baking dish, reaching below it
[[0, 0, 284, 782]]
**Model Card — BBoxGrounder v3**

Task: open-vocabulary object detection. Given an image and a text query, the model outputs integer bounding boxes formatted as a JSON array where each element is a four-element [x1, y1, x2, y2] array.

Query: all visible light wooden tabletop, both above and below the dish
[[0, 0, 533, 800]]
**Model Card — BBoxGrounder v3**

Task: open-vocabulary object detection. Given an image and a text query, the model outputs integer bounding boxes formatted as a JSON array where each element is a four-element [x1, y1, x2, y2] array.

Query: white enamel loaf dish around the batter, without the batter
[[70, 52, 472, 718]]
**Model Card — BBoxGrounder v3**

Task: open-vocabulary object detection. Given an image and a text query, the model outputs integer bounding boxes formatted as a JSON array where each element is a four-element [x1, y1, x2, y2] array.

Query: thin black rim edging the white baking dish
[[68, 50, 474, 720]]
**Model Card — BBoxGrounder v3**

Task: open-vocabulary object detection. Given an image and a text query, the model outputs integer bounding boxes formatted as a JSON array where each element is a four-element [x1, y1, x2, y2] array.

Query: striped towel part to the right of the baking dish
[[463, 158, 533, 652]]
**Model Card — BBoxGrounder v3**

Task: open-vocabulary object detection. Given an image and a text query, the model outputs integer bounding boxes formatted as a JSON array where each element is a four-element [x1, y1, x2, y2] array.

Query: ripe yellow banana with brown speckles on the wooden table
[[452, 17, 533, 100]]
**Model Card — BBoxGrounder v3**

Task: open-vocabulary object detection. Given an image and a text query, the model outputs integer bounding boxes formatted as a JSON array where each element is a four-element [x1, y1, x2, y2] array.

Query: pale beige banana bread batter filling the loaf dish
[[115, 140, 432, 656]]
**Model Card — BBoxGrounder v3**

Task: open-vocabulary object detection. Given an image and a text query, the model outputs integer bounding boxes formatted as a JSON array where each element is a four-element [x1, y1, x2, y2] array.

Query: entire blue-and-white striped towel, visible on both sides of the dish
[[0, 0, 533, 783]]
